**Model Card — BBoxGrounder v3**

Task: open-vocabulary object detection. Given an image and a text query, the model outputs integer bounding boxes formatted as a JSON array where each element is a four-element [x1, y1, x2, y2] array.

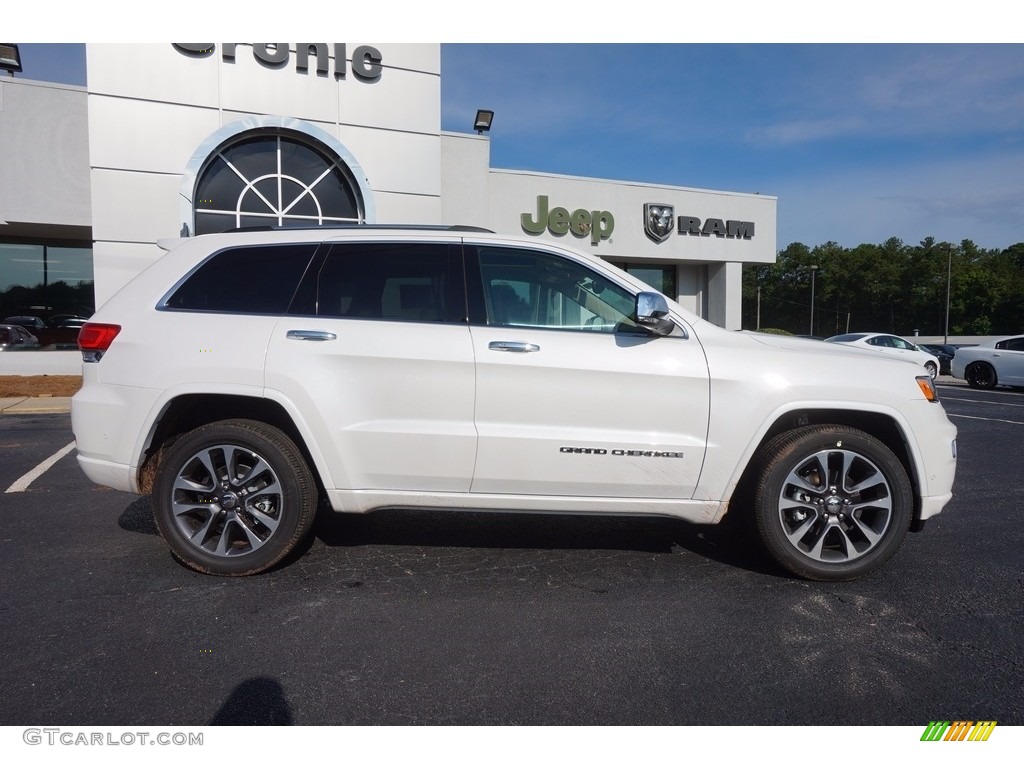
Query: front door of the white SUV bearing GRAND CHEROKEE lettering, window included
[[467, 246, 709, 499]]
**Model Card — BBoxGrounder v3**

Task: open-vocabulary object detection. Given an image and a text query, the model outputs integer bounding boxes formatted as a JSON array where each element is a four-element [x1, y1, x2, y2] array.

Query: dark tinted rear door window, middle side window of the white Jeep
[[315, 243, 456, 323]]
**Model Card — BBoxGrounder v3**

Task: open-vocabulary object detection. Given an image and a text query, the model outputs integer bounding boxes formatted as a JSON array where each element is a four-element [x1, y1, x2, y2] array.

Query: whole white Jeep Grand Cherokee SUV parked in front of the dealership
[[72, 226, 956, 580]]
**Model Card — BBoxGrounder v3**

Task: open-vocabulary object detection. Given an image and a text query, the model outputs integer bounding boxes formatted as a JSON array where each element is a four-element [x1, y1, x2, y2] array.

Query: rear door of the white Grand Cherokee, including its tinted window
[[266, 242, 476, 493]]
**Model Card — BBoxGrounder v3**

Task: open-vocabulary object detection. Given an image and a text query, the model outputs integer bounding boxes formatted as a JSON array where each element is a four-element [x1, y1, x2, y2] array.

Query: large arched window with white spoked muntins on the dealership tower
[[194, 129, 366, 234]]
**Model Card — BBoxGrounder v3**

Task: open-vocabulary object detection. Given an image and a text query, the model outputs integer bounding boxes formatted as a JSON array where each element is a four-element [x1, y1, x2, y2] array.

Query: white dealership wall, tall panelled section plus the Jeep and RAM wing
[[79, 43, 776, 328]]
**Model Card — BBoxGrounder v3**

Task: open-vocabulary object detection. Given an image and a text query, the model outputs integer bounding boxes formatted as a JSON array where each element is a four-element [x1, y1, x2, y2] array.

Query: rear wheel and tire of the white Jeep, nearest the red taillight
[[153, 419, 317, 575]]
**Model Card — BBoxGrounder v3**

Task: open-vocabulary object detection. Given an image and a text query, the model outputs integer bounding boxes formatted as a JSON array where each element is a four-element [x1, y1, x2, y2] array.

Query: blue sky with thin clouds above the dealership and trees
[[9, 38, 1024, 249]]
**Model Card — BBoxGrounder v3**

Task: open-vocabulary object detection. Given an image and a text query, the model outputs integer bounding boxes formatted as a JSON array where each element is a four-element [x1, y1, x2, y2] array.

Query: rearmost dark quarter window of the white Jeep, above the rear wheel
[[166, 243, 317, 314]]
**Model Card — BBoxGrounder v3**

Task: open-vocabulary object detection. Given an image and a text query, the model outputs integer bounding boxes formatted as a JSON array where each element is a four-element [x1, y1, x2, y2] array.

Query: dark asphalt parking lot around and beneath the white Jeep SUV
[[0, 385, 1024, 728]]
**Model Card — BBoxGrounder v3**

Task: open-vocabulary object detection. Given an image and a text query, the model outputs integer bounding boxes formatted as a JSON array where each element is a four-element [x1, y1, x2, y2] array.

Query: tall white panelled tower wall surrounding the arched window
[[82, 43, 442, 305]]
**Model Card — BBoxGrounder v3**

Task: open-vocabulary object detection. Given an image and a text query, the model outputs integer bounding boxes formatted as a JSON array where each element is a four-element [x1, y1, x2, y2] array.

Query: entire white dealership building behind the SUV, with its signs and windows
[[0, 42, 776, 329]]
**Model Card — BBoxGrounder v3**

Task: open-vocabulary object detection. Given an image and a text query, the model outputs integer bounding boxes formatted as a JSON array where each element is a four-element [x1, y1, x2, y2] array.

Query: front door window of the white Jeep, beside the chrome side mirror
[[478, 248, 642, 333]]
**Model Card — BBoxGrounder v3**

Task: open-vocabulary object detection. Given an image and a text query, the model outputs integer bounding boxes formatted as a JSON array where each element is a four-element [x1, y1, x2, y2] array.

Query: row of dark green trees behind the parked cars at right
[[742, 238, 1024, 337]]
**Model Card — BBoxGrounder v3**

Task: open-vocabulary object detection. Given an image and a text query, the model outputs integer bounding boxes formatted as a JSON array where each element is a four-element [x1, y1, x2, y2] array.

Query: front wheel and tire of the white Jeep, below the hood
[[754, 424, 913, 582]]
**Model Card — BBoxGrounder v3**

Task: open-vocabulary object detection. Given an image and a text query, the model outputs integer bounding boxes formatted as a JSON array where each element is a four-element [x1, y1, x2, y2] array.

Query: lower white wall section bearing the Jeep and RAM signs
[[441, 159, 777, 329]]
